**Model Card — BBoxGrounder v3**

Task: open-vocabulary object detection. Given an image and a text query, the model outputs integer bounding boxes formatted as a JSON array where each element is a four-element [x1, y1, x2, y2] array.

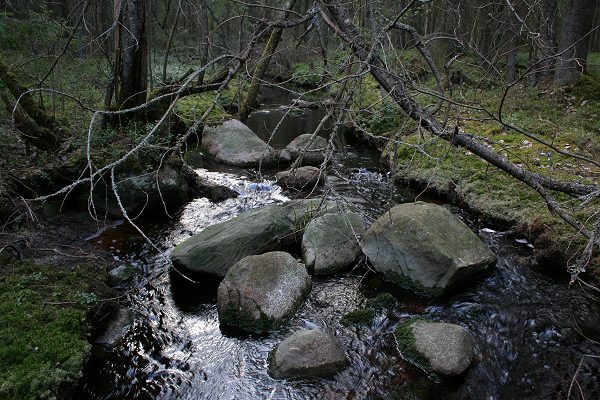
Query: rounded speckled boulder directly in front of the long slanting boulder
[[217, 251, 312, 333]]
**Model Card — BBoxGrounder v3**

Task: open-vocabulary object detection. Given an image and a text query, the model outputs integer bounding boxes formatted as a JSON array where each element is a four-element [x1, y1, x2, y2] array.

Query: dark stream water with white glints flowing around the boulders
[[82, 98, 600, 400]]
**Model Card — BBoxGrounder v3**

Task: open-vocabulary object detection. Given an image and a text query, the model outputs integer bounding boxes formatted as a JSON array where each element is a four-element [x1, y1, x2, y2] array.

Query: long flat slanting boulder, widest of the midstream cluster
[[171, 199, 337, 278]]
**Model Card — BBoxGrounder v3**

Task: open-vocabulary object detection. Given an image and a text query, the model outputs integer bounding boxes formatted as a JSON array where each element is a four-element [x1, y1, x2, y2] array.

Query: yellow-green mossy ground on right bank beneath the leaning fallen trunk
[[385, 80, 600, 268]]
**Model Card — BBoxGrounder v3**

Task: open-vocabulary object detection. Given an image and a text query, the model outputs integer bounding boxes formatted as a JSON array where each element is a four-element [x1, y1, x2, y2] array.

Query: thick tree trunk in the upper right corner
[[554, 0, 598, 86]]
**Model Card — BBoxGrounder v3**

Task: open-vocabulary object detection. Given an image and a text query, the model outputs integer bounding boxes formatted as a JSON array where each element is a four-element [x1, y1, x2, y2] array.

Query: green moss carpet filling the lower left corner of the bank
[[0, 262, 96, 399]]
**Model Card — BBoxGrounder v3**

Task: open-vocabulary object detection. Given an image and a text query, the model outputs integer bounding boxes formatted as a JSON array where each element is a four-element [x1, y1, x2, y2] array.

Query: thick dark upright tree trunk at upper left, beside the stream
[[115, 0, 148, 109]]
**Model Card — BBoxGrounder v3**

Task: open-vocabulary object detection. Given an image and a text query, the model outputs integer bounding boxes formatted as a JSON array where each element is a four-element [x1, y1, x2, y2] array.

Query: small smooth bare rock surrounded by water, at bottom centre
[[269, 329, 348, 379]]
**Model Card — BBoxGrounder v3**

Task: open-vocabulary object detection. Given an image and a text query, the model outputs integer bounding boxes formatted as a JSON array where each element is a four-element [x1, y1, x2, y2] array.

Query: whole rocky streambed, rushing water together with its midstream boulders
[[79, 107, 600, 399]]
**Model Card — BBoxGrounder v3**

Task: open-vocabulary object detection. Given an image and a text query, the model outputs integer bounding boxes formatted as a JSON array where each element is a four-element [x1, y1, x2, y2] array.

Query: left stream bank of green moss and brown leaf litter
[[0, 205, 119, 399]]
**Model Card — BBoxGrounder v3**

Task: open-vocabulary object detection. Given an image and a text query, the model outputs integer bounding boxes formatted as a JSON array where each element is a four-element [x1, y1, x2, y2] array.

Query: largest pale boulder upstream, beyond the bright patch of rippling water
[[202, 119, 276, 167]]
